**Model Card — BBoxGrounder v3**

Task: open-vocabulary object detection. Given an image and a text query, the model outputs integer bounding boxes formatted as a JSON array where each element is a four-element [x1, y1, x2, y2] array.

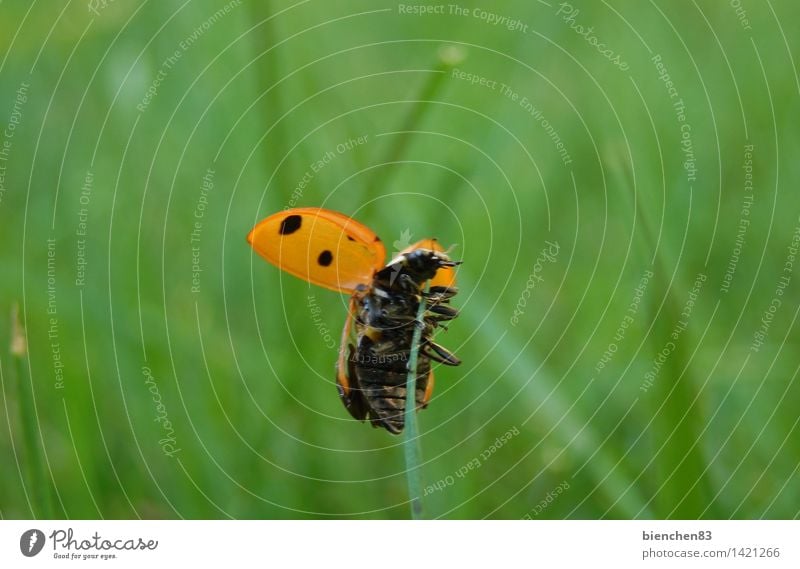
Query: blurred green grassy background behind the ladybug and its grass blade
[[0, 0, 800, 519]]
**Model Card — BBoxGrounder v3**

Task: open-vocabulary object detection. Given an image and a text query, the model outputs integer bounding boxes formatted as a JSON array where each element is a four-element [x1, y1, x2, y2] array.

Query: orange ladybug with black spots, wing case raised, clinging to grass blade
[[248, 208, 461, 434]]
